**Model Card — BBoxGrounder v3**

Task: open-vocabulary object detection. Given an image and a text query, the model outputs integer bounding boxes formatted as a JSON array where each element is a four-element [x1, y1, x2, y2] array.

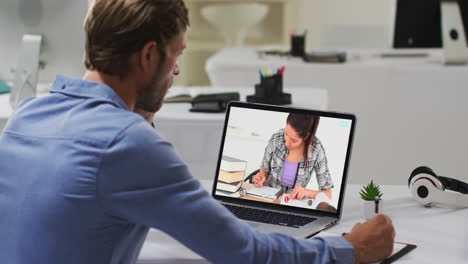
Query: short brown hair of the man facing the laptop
[[84, 0, 189, 78]]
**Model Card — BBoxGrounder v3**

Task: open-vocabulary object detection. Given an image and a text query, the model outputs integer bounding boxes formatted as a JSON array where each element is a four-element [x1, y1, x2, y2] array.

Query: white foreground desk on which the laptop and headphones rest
[[138, 180, 468, 264]]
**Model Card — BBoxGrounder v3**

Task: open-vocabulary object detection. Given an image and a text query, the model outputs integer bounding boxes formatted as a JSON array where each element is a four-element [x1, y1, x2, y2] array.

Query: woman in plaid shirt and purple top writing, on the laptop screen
[[253, 113, 333, 206]]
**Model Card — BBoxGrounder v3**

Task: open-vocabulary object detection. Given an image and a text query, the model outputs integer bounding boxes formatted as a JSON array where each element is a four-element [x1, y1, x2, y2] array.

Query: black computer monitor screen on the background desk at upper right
[[393, 0, 468, 48]]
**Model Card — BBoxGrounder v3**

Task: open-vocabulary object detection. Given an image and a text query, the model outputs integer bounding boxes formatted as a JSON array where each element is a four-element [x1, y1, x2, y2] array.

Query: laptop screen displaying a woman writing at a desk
[[213, 102, 355, 215]]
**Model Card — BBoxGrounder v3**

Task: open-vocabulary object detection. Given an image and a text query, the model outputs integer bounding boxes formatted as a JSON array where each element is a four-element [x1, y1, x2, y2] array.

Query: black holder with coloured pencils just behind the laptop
[[247, 74, 291, 105]]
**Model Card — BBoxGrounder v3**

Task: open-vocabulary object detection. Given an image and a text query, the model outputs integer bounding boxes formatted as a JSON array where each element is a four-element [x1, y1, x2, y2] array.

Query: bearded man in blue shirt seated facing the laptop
[[0, 0, 395, 264]]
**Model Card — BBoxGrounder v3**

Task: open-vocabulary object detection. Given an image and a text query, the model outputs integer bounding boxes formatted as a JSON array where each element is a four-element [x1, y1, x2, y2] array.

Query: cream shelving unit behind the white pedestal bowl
[[175, 0, 297, 86]]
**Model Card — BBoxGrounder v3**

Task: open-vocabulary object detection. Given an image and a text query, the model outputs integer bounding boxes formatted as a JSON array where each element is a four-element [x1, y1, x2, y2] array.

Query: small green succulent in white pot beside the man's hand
[[359, 180, 383, 219]]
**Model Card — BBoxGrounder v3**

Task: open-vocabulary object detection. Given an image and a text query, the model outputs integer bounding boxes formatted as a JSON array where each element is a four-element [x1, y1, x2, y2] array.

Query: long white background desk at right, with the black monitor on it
[[206, 49, 468, 184]]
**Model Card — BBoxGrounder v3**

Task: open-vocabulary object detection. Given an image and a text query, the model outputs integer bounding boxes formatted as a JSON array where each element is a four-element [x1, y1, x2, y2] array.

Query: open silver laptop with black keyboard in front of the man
[[212, 102, 356, 238]]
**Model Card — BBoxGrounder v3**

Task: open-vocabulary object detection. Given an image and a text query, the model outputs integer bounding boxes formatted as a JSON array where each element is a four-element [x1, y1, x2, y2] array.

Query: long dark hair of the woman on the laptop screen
[[286, 113, 320, 167]]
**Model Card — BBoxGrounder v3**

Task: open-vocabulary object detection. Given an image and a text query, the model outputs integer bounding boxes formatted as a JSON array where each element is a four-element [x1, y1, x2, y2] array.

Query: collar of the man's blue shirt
[[50, 74, 128, 110]]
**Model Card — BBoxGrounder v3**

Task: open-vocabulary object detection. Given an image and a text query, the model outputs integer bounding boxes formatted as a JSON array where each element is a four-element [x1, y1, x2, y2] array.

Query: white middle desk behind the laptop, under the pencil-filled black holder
[[0, 87, 328, 179]]
